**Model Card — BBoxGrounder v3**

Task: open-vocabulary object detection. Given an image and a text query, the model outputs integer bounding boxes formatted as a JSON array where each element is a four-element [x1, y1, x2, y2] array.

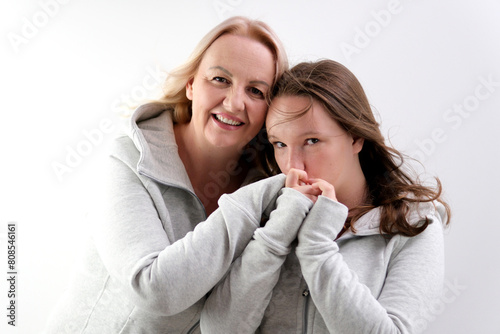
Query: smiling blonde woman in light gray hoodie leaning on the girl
[[46, 17, 287, 334]]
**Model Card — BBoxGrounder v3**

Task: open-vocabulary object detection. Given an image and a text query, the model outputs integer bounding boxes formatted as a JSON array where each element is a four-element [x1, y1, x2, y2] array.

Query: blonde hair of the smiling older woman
[[154, 16, 288, 123]]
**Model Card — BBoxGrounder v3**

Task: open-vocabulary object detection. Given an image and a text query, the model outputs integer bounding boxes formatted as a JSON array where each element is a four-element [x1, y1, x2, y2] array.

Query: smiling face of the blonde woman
[[186, 34, 275, 149]]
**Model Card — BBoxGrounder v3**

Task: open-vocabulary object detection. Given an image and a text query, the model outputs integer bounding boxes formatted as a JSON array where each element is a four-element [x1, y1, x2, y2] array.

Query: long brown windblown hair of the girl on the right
[[266, 60, 450, 236]]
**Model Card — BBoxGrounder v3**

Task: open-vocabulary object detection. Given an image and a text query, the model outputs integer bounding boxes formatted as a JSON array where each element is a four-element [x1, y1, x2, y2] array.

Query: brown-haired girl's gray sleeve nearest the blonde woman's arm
[[200, 188, 313, 334]]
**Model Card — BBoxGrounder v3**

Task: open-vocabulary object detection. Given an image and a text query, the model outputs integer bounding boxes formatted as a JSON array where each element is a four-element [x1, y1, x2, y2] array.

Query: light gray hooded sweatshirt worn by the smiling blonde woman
[[46, 105, 285, 334]]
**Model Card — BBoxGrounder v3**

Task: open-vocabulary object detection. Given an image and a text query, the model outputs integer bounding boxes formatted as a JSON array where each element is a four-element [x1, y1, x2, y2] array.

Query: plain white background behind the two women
[[0, 0, 500, 334]]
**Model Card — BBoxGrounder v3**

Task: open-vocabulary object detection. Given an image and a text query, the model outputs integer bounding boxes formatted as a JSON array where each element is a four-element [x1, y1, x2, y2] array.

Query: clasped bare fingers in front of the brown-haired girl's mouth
[[285, 168, 338, 203]]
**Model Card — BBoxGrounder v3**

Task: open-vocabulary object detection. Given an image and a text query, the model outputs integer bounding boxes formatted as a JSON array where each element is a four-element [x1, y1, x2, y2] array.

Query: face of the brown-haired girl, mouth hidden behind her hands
[[266, 96, 363, 196]]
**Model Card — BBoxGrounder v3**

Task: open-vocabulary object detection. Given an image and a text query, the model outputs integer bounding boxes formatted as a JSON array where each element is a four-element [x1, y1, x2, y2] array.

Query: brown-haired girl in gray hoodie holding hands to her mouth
[[201, 60, 449, 334]]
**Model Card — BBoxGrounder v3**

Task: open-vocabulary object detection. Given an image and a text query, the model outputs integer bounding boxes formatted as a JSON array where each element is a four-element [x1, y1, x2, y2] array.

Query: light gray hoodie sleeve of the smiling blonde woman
[[93, 155, 285, 315]]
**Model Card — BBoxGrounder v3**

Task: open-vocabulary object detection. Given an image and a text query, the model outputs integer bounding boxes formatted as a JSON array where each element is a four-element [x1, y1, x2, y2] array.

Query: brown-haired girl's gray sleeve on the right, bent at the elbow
[[296, 196, 444, 334]]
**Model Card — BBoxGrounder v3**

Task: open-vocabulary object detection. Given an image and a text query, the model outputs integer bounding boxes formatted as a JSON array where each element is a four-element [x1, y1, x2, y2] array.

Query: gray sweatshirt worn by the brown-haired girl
[[201, 189, 446, 334]]
